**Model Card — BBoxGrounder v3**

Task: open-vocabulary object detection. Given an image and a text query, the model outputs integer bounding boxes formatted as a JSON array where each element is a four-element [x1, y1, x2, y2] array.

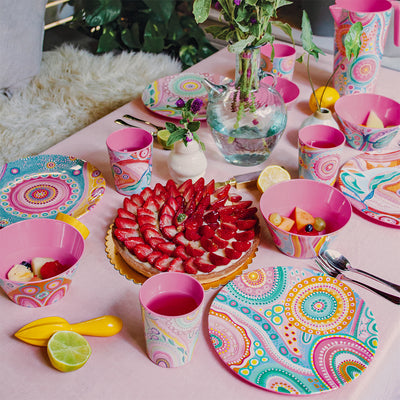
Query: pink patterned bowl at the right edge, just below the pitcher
[[335, 93, 400, 151]]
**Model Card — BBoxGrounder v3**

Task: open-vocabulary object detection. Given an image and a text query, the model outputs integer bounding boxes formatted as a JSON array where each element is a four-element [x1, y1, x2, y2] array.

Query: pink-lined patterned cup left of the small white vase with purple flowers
[[106, 128, 153, 196]]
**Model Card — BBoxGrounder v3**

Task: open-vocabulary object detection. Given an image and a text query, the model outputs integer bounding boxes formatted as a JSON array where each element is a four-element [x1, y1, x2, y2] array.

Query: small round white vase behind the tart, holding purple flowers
[[168, 140, 207, 183]]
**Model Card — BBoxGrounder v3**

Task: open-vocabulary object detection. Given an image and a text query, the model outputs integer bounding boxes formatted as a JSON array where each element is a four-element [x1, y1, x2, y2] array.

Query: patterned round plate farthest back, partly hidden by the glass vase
[[142, 73, 227, 120]]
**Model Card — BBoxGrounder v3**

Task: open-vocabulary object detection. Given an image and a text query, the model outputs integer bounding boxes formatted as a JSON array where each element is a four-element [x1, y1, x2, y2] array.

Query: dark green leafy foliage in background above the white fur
[[69, 0, 216, 69]]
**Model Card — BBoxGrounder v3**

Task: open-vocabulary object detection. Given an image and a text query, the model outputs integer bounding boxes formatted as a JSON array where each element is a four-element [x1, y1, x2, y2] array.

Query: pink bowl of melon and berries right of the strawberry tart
[[260, 179, 351, 258]]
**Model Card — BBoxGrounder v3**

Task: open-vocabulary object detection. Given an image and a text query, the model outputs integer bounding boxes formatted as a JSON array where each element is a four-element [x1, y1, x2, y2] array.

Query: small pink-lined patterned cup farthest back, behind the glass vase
[[261, 43, 296, 81]]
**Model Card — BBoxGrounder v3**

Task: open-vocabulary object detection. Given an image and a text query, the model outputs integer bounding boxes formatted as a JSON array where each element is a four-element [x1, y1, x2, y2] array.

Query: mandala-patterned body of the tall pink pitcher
[[333, 9, 391, 95]]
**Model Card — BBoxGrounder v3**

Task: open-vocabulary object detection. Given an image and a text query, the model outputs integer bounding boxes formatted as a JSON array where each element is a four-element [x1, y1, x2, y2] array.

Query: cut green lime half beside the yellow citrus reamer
[[47, 331, 92, 372]]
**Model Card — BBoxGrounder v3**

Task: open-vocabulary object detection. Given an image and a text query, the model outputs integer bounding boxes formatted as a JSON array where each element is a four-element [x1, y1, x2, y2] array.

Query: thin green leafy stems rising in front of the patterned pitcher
[[297, 10, 363, 110]]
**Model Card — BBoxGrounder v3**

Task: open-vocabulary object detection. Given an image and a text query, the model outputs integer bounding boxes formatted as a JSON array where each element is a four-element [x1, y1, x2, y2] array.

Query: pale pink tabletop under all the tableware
[[0, 46, 400, 400]]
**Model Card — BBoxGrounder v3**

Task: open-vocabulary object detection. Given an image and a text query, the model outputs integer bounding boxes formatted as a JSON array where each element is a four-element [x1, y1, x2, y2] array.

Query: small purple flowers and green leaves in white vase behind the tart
[[165, 97, 205, 151]]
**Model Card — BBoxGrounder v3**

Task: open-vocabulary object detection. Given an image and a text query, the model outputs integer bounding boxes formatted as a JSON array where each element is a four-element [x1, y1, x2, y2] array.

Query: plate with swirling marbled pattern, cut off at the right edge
[[338, 150, 400, 228]]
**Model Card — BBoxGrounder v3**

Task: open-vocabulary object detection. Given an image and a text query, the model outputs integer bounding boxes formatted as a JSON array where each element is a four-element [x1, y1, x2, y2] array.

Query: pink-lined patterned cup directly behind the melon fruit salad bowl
[[299, 125, 346, 186]]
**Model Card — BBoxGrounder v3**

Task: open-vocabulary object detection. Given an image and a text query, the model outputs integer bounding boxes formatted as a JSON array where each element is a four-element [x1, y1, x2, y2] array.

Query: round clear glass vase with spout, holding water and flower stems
[[207, 48, 287, 166]]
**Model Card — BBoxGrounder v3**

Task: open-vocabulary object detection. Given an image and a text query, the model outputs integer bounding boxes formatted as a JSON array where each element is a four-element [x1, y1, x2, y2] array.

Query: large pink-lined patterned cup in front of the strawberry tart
[[139, 272, 204, 368]]
